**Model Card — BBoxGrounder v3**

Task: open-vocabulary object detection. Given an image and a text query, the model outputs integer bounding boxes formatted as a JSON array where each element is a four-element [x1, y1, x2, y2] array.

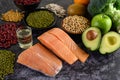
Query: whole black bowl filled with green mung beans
[[24, 9, 57, 30]]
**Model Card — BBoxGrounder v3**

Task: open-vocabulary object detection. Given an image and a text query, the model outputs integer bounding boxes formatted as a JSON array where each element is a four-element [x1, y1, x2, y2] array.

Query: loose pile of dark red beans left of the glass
[[0, 23, 17, 48]]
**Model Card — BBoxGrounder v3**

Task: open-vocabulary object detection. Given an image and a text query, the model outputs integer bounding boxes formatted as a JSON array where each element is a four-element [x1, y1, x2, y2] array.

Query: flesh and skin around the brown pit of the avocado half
[[82, 27, 101, 51]]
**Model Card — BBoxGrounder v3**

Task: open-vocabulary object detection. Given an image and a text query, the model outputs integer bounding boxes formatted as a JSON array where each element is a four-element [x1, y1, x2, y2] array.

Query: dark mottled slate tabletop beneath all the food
[[0, 0, 120, 80]]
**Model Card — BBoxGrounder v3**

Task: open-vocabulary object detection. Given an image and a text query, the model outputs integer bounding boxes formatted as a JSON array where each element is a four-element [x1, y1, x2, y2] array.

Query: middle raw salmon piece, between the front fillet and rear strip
[[38, 32, 78, 64]]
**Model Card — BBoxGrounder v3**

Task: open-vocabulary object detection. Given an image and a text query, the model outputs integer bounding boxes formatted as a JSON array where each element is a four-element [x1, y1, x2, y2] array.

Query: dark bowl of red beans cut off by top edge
[[14, 0, 41, 11]]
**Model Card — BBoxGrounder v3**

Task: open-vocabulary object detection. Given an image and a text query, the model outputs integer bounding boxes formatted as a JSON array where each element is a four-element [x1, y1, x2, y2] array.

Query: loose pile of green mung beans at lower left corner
[[0, 50, 15, 80]]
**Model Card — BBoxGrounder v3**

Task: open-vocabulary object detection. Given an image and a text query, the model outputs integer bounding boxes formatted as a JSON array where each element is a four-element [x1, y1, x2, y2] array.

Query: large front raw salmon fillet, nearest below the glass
[[17, 43, 62, 76]]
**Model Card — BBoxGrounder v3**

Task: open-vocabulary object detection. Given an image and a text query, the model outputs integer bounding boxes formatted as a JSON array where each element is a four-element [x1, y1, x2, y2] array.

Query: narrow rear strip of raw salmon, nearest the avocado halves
[[48, 28, 89, 62]]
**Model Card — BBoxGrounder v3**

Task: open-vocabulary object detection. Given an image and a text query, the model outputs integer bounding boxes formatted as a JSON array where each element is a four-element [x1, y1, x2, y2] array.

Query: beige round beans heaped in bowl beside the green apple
[[62, 15, 90, 34]]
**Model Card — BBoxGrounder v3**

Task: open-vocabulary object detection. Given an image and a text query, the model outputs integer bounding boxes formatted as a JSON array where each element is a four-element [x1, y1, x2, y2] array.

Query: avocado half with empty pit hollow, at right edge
[[99, 31, 120, 54]]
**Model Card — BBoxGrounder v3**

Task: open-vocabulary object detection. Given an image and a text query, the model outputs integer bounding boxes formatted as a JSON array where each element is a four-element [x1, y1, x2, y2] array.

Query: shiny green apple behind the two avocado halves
[[91, 14, 112, 34]]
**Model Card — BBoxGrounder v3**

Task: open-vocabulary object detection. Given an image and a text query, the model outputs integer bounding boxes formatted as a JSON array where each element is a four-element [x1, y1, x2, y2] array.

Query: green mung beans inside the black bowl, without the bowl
[[26, 10, 54, 28]]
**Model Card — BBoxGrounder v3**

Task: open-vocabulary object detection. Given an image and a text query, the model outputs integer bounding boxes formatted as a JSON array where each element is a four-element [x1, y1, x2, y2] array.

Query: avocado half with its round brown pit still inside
[[82, 27, 101, 51]]
